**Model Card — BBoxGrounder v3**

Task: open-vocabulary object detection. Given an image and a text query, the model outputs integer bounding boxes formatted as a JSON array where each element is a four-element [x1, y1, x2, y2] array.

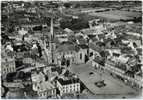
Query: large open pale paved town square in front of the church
[[69, 62, 138, 97]]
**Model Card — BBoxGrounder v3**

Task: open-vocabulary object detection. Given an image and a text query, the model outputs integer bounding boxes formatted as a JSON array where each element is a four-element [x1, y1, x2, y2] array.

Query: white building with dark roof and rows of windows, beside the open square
[[57, 78, 80, 96]]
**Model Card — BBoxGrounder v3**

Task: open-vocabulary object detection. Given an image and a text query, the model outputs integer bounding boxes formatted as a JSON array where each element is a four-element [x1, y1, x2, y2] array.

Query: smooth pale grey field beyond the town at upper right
[[89, 10, 142, 20]]
